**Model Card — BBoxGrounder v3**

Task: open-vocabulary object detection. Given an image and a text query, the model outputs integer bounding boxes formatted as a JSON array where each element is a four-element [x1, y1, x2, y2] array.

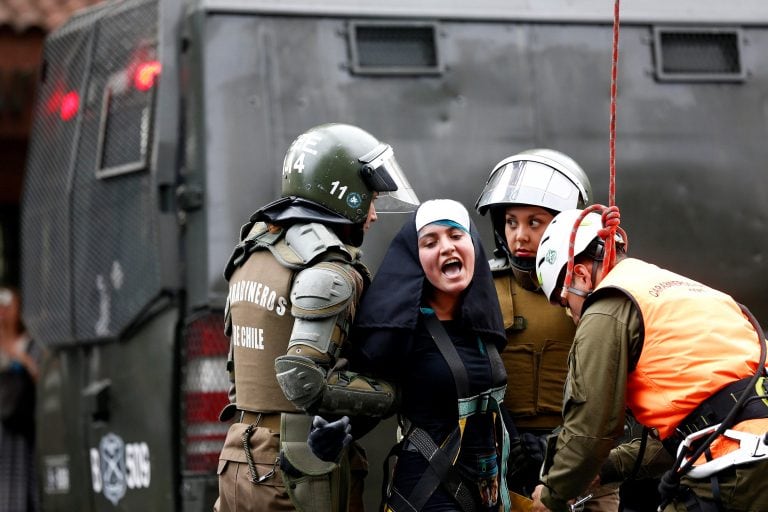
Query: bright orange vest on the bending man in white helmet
[[585, 259, 760, 439]]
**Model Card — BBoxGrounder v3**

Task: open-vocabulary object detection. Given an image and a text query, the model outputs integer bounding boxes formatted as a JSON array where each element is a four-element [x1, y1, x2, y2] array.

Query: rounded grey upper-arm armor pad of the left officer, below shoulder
[[291, 262, 358, 318]]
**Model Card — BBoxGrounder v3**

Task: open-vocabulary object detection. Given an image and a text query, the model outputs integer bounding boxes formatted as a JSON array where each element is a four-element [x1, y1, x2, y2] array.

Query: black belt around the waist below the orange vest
[[662, 376, 768, 457]]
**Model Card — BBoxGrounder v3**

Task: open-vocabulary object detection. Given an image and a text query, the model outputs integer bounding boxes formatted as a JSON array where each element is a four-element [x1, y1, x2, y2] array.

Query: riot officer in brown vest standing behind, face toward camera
[[475, 148, 618, 510]]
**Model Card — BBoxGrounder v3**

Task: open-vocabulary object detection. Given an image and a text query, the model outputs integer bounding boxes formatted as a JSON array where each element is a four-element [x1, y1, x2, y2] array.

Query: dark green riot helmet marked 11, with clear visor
[[282, 123, 419, 224]]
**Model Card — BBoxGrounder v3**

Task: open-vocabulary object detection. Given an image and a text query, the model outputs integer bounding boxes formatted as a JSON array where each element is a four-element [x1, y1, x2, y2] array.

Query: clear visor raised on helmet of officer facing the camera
[[477, 161, 586, 212]]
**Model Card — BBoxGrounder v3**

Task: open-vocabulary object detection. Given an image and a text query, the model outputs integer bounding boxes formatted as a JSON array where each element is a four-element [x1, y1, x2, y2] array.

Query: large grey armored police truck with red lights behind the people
[[22, 0, 768, 512]]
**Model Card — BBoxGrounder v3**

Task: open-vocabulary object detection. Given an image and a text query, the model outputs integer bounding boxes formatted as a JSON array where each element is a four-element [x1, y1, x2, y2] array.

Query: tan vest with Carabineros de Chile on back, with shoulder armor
[[225, 222, 369, 414]]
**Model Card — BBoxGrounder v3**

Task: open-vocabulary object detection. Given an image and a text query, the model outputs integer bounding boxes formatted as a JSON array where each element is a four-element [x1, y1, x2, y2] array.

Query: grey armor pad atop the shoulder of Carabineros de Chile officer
[[270, 222, 353, 268]]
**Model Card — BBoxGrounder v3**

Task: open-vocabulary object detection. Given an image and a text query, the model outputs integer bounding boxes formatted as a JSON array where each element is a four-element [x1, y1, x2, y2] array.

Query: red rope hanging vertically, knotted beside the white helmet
[[560, 0, 627, 301]]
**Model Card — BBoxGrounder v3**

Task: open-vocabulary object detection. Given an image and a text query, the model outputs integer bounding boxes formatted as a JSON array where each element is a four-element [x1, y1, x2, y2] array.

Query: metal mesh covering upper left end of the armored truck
[[22, 1, 160, 344]]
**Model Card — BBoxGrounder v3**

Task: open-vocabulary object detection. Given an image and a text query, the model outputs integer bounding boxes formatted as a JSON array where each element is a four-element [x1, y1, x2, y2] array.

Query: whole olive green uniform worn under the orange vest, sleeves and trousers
[[541, 291, 768, 512]]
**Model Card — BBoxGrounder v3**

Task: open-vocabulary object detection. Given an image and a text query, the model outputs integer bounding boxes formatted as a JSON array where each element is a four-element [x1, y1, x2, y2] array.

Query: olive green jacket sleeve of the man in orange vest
[[541, 292, 642, 511]]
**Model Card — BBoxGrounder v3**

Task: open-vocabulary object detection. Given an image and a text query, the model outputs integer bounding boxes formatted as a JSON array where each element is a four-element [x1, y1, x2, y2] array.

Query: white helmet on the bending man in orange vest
[[536, 210, 603, 304]]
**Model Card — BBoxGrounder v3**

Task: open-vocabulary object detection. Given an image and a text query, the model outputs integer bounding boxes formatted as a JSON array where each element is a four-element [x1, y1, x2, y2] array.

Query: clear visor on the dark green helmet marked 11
[[360, 144, 419, 213]]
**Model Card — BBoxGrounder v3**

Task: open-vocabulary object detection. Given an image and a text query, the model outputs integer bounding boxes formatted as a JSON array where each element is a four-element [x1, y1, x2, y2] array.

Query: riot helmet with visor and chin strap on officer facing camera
[[475, 148, 592, 272]]
